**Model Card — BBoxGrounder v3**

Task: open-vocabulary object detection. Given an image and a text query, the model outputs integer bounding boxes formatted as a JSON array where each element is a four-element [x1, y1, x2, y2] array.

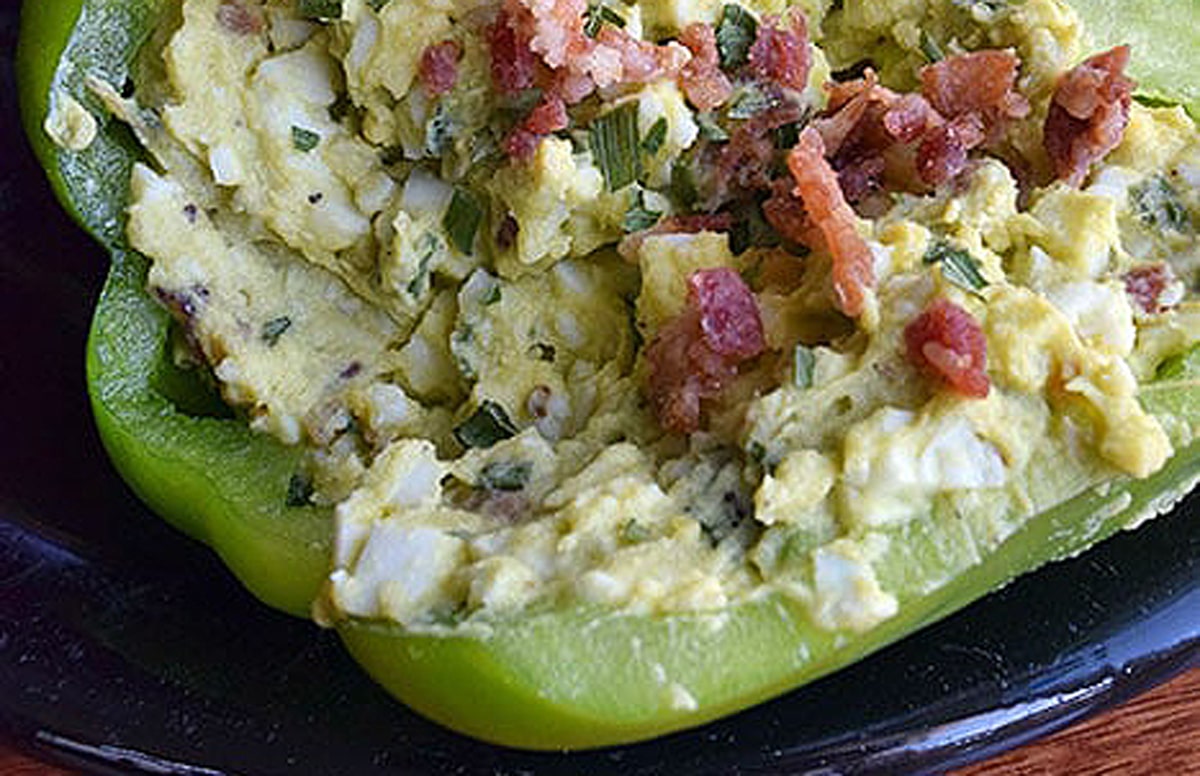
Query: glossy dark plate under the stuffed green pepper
[[0, 7, 1200, 774]]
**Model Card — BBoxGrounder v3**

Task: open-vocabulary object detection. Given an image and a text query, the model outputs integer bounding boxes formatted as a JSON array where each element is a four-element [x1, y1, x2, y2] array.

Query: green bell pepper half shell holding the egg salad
[[18, 0, 1200, 750]]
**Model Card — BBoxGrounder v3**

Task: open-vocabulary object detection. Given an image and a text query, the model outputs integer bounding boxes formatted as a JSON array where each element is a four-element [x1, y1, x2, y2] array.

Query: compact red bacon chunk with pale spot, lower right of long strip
[[904, 299, 991, 398]]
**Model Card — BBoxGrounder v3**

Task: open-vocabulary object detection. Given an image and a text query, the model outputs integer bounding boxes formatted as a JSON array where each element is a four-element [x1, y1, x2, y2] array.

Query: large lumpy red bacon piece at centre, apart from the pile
[[646, 267, 767, 434]]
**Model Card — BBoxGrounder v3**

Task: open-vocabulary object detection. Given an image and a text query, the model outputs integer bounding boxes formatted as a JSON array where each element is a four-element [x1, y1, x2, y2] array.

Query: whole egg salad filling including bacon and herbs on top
[[79, 0, 1200, 631]]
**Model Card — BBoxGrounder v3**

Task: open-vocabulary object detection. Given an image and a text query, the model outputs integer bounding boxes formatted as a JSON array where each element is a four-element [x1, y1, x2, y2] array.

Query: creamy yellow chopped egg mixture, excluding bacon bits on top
[[82, 0, 1200, 638]]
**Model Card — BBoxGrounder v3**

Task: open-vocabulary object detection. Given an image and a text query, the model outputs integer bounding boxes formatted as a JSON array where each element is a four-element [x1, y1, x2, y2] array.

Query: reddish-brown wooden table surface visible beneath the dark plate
[[0, 668, 1200, 776]]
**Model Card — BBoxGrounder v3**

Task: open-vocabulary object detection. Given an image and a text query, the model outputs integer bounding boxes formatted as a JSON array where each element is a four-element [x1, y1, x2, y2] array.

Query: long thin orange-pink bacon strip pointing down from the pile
[[787, 127, 875, 318]]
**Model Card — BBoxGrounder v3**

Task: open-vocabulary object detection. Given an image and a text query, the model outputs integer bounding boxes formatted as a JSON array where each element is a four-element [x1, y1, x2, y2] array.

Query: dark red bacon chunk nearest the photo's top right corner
[[1043, 46, 1134, 186]]
